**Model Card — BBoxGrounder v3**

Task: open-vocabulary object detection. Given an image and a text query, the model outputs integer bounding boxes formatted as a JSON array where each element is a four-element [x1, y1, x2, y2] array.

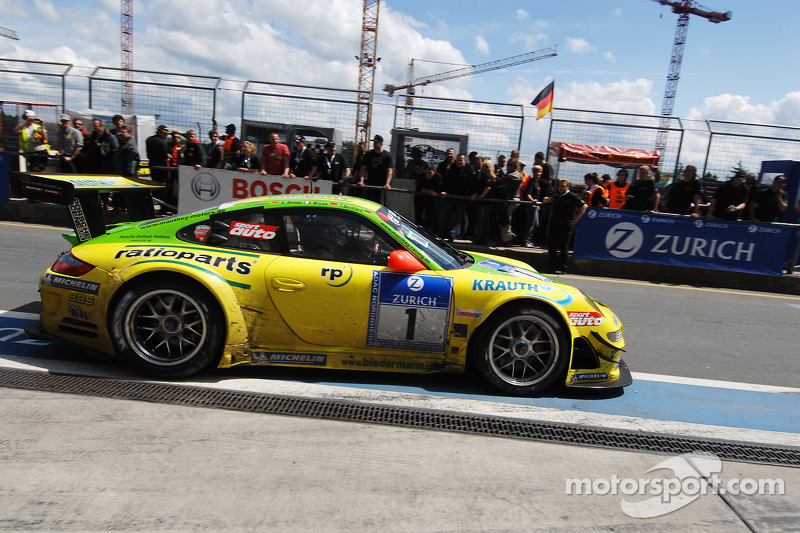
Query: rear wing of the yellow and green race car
[[9, 172, 164, 242]]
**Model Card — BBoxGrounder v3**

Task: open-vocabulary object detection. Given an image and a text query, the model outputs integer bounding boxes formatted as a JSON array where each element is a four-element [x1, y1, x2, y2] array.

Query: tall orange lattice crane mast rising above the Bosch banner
[[353, 0, 381, 148]]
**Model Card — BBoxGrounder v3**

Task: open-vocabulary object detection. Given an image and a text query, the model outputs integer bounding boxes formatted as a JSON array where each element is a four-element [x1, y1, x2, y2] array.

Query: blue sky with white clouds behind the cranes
[[0, 0, 800, 162]]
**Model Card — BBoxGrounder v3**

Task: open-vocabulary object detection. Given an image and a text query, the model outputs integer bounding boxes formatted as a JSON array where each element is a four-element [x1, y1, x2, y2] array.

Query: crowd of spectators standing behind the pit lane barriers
[[16, 114, 787, 249]]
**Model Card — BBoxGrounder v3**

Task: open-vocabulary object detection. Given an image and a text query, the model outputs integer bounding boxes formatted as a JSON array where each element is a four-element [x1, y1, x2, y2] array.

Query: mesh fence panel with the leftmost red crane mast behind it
[[89, 67, 220, 138]]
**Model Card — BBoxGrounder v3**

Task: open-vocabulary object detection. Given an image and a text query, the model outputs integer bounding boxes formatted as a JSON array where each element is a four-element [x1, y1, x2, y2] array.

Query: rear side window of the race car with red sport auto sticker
[[178, 208, 281, 253]]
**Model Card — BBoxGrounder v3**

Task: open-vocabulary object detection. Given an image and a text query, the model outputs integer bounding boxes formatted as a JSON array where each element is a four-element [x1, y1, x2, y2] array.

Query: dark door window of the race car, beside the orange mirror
[[281, 209, 400, 266]]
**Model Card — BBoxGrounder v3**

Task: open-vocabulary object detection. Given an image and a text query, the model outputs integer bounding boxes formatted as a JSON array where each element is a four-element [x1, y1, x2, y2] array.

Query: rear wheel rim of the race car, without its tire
[[125, 290, 208, 366]]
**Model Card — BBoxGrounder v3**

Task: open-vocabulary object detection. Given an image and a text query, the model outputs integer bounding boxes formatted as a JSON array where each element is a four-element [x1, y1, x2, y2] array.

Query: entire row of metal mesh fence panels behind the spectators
[[0, 59, 800, 181]]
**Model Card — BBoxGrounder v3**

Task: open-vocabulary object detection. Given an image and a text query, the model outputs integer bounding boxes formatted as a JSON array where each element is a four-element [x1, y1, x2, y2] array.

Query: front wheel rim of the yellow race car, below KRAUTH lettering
[[489, 316, 560, 386]]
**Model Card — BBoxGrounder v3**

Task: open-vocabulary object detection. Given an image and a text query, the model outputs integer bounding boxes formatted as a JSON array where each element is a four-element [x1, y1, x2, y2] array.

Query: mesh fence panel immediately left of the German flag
[[394, 96, 525, 159]]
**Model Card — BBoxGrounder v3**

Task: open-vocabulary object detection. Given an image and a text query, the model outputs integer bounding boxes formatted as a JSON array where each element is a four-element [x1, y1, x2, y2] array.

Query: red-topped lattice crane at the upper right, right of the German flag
[[653, 0, 733, 162]]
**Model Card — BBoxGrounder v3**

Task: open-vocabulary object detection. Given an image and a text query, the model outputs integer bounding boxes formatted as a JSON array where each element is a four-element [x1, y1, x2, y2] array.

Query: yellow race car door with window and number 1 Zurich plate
[[265, 208, 452, 355]]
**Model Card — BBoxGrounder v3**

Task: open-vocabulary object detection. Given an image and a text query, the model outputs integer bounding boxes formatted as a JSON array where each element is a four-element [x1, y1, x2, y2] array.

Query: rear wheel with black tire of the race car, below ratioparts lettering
[[109, 278, 225, 378]]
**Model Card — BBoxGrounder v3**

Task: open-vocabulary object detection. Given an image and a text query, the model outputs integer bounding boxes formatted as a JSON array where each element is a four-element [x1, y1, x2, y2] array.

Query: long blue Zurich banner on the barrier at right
[[574, 207, 797, 276]]
